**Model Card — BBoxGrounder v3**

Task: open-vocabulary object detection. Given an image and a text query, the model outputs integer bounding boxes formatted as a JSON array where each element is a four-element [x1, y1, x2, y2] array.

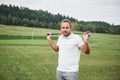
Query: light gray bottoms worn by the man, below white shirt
[[56, 71, 78, 80]]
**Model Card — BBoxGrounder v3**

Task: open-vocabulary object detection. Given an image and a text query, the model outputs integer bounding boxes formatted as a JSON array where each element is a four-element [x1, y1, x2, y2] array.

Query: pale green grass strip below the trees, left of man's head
[[0, 25, 59, 36]]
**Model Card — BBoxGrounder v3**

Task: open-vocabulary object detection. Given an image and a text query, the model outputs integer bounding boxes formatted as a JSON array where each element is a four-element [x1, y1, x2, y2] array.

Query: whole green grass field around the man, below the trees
[[0, 25, 120, 80]]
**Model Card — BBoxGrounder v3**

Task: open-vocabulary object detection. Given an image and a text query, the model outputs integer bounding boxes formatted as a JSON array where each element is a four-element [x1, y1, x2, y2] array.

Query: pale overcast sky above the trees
[[0, 0, 120, 25]]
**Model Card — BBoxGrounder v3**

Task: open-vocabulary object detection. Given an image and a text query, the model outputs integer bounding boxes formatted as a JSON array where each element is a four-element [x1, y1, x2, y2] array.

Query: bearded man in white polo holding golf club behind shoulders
[[47, 19, 91, 80]]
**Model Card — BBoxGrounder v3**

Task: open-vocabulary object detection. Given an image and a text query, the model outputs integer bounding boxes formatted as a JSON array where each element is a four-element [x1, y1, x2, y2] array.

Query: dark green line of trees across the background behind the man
[[0, 4, 120, 34]]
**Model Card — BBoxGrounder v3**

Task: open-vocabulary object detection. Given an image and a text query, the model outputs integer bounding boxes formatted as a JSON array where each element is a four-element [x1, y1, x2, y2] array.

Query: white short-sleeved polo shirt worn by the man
[[57, 33, 84, 72]]
